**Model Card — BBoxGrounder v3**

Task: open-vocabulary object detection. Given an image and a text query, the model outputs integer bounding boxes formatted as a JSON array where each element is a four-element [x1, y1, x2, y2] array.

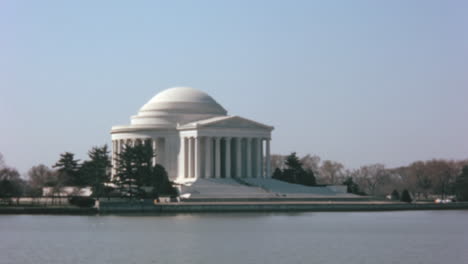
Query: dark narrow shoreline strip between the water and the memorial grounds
[[0, 201, 468, 215]]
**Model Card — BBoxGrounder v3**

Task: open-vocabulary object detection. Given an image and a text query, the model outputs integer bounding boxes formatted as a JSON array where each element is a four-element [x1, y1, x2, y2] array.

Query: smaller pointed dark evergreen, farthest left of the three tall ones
[[52, 152, 80, 186]]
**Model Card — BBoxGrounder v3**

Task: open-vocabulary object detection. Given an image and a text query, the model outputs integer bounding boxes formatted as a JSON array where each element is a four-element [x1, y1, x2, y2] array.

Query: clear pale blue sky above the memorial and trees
[[0, 0, 468, 173]]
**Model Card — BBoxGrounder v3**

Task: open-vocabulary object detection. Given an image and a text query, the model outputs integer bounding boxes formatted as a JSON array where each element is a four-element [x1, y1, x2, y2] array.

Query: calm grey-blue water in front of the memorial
[[0, 211, 468, 264]]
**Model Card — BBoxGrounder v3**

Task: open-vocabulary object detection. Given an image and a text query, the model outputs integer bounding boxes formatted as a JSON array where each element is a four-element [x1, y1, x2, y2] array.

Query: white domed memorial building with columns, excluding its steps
[[111, 87, 273, 184]]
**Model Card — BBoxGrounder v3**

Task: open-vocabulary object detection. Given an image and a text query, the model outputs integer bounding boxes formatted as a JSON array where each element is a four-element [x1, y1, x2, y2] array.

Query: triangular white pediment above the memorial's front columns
[[179, 116, 273, 130]]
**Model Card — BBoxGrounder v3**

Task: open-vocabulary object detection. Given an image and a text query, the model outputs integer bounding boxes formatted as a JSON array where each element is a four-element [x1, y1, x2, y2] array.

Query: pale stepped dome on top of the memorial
[[131, 87, 227, 127]]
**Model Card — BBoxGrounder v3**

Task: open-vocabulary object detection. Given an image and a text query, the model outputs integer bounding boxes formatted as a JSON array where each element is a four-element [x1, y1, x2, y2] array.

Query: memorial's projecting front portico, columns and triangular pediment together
[[178, 116, 271, 179]]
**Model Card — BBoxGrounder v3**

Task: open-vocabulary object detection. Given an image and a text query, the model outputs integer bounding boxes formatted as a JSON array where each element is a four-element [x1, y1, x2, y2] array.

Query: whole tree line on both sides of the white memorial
[[0, 148, 468, 200]]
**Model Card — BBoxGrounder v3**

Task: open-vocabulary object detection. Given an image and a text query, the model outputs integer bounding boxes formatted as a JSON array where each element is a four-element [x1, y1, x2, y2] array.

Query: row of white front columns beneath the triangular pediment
[[179, 136, 271, 179]]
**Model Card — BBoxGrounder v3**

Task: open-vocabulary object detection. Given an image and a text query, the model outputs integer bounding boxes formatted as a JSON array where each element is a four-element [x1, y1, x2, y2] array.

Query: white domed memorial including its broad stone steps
[[111, 87, 354, 198]]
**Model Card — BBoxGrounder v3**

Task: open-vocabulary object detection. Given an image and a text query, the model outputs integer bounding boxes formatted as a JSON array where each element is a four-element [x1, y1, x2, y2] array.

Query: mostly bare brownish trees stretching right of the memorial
[[271, 153, 468, 200]]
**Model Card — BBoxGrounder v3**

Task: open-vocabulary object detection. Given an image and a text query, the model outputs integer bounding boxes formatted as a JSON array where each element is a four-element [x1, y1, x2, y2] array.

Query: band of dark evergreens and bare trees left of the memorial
[[0, 142, 176, 198]]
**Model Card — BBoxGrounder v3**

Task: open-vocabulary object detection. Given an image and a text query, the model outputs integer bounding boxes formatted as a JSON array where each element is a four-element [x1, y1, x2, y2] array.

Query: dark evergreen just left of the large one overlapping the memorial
[[78, 145, 111, 197]]
